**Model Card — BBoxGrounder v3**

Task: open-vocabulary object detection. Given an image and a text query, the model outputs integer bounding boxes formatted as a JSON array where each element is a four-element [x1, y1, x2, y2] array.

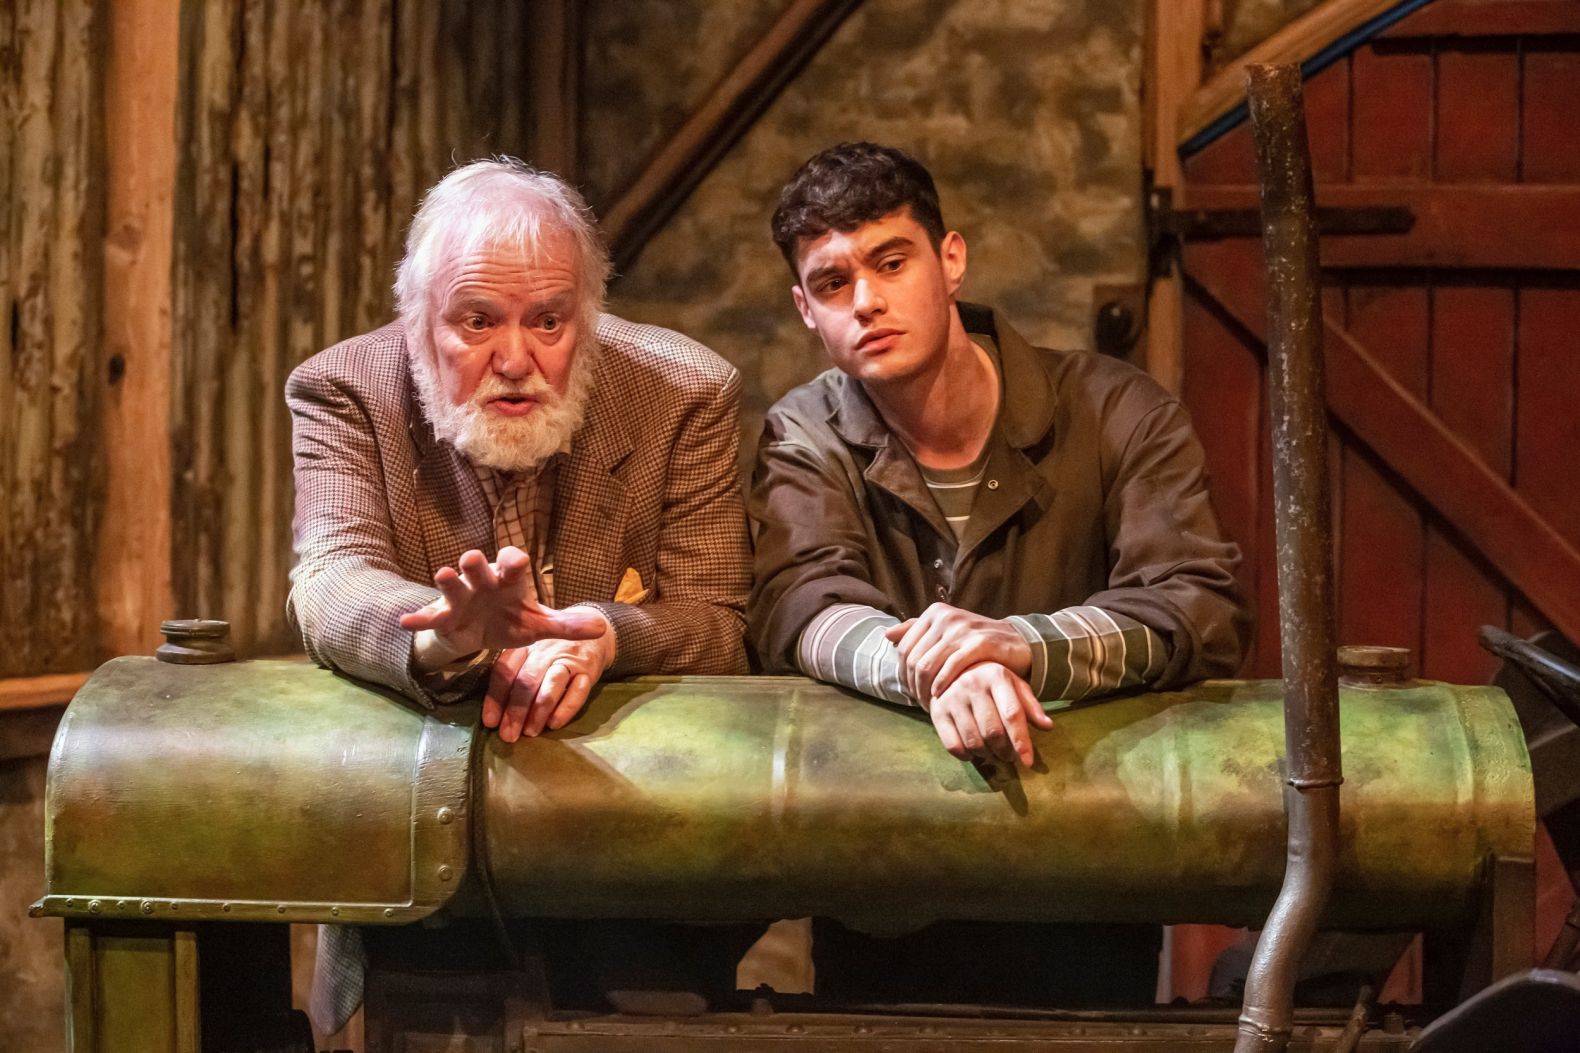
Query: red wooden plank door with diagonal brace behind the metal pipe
[[1174, 0, 1580, 996]]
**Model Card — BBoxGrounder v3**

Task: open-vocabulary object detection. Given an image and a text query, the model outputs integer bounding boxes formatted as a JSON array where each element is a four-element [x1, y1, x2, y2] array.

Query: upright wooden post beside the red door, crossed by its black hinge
[[1144, 0, 1207, 394]]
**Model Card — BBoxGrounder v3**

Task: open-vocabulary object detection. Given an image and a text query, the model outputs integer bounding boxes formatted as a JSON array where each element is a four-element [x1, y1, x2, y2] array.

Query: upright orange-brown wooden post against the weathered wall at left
[[96, 0, 180, 655]]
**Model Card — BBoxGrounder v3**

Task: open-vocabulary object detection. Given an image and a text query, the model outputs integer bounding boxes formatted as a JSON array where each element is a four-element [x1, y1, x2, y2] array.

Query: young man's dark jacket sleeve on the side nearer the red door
[[1087, 378, 1250, 689]]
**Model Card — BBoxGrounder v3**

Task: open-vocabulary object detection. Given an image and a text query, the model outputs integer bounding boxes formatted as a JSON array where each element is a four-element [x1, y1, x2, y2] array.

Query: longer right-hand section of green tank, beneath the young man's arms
[[482, 678, 1533, 928]]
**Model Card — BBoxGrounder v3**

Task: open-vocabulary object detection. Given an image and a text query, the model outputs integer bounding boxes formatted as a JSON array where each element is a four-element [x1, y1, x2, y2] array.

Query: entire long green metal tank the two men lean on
[[40, 658, 1534, 930]]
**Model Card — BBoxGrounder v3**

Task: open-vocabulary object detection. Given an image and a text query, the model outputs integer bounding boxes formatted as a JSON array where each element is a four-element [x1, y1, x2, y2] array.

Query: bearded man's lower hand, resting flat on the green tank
[[483, 610, 615, 742]]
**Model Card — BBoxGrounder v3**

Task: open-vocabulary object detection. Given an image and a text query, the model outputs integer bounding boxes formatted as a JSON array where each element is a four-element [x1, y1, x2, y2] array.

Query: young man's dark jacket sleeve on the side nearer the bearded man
[[747, 406, 896, 674]]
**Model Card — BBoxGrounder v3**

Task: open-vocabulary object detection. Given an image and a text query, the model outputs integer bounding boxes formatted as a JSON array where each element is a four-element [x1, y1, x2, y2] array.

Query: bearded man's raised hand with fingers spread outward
[[400, 545, 608, 672]]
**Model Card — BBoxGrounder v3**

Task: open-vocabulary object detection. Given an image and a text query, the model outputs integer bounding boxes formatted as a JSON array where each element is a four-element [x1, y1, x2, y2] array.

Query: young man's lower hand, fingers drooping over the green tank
[[926, 662, 1054, 767]]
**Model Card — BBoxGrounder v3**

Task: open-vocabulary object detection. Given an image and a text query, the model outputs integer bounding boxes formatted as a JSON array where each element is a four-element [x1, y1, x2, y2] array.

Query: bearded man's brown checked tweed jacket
[[286, 315, 751, 704]]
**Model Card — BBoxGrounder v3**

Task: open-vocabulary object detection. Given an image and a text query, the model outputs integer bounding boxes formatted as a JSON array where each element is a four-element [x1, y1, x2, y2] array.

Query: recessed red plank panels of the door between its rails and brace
[[1185, 21, 1580, 683]]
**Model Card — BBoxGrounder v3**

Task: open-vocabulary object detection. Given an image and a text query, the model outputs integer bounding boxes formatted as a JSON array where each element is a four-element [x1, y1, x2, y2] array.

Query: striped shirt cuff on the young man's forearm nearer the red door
[[1008, 606, 1169, 702]]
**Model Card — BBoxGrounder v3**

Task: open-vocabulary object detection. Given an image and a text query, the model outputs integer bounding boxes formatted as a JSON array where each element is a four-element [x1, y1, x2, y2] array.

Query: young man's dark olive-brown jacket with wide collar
[[747, 304, 1248, 688]]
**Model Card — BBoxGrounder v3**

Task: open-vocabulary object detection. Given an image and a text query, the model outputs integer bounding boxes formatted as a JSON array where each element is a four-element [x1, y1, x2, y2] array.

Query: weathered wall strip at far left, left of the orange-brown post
[[0, 0, 106, 677]]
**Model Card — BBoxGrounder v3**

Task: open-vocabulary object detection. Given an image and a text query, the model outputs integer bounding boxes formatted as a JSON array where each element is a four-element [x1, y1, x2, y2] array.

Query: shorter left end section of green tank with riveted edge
[[38, 658, 472, 923]]
